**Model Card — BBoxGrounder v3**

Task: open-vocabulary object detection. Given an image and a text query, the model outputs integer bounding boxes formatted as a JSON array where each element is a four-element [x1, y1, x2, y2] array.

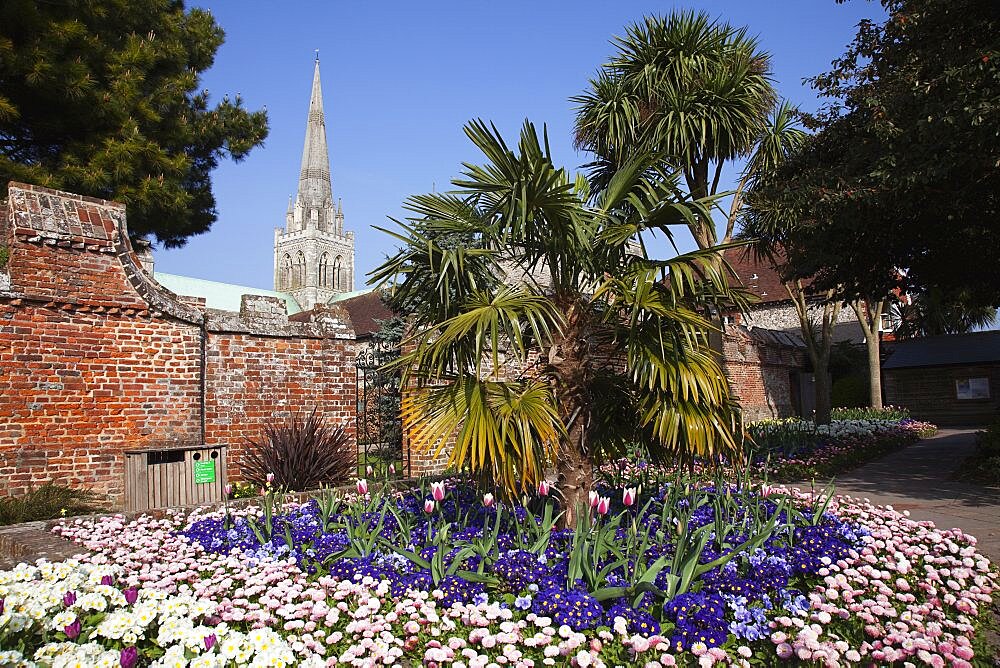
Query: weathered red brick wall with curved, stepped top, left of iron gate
[[0, 184, 355, 504]]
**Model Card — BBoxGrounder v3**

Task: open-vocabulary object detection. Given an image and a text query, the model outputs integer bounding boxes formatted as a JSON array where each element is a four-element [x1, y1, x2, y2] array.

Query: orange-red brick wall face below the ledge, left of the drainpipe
[[0, 299, 201, 498]]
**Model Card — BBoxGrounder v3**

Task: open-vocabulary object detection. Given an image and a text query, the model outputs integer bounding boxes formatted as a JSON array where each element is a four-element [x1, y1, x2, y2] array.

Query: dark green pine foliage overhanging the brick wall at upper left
[[0, 0, 267, 246]]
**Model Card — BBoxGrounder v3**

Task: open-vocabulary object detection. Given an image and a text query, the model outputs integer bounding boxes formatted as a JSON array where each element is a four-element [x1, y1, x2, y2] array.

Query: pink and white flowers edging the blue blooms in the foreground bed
[[0, 480, 997, 668]]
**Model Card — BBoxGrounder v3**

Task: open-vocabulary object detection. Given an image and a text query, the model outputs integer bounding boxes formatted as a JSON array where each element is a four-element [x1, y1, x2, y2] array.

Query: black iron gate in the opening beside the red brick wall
[[354, 341, 410, 476]]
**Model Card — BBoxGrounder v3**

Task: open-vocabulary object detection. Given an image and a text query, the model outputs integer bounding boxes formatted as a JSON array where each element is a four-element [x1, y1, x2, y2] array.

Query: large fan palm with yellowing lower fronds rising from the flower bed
[[371, 121, 738, 524]]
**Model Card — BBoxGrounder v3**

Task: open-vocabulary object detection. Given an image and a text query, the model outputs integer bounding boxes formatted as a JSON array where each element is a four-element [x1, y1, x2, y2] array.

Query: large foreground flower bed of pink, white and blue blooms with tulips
[[0, 474, 996, 667]]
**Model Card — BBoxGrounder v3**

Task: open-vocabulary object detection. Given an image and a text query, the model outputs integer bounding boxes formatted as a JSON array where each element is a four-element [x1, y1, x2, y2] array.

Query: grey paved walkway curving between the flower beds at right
[[808, 429, 1000, 562]]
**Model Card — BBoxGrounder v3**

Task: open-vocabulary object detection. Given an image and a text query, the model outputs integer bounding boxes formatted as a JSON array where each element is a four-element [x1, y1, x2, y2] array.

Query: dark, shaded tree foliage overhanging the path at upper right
[[746, 0, 1000, 306]]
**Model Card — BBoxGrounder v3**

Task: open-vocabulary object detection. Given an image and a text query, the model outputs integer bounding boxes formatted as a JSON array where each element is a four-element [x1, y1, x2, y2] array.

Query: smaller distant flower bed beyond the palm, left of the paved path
[[747, 418, 937, 481]]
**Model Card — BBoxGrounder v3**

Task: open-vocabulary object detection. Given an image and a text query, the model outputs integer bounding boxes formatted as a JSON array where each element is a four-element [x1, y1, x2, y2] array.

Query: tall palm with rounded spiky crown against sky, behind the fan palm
[[573, 11, 804, 249]]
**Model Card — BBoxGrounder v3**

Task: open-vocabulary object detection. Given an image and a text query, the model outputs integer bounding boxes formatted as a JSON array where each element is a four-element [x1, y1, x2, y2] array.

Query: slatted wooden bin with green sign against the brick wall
[[125, 445, 226, 510]]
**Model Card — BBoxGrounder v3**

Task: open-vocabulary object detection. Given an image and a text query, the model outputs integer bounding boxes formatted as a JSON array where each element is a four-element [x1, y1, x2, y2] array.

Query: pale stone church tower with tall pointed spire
[[274, 53, 354, 310]]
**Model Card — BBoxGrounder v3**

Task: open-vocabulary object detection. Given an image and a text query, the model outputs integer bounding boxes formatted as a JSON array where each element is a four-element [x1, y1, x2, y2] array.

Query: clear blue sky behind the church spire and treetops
[[156, 0, 881, 289]]
